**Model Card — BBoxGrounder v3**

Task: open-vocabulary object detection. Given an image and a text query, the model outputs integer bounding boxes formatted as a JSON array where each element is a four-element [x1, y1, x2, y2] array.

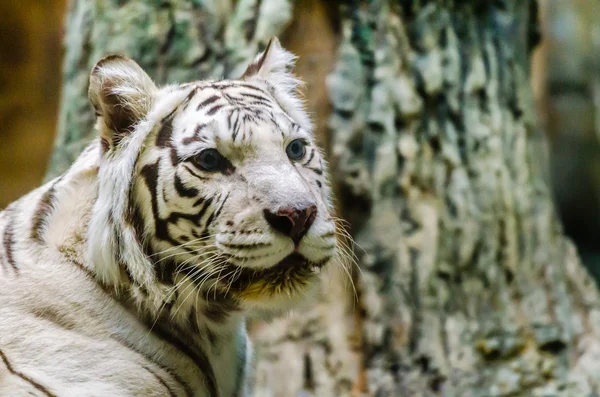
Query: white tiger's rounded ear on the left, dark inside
[[88, 55, 157, 149]]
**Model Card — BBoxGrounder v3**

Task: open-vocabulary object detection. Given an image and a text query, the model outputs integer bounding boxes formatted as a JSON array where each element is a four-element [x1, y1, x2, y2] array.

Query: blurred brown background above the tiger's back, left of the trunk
[[0, 0, 66, 209]]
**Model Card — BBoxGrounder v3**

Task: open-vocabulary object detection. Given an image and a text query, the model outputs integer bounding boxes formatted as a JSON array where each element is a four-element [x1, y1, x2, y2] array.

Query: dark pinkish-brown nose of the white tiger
[[263, 205, 317, 245]]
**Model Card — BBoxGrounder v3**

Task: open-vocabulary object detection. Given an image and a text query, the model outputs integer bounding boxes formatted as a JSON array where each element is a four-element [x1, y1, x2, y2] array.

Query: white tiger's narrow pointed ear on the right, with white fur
[[241, 37, 311, 130]]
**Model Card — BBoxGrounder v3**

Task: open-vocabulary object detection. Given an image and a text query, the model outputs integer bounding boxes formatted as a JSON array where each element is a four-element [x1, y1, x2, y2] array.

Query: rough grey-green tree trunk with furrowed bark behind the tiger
[[51, 0, 600, 397]]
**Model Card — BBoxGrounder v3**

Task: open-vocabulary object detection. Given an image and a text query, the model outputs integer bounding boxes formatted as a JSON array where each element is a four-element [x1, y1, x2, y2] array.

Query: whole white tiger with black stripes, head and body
[[0, 39, 338, 397]]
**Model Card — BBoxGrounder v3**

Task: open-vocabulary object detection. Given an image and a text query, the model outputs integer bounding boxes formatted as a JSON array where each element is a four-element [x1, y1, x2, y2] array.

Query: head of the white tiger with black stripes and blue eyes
[[88, 39, 338, 310]]
